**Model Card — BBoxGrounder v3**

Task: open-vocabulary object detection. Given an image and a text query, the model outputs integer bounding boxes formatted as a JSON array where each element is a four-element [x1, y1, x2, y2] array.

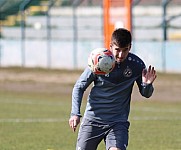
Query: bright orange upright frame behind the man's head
[[103, 0, 132, 48]]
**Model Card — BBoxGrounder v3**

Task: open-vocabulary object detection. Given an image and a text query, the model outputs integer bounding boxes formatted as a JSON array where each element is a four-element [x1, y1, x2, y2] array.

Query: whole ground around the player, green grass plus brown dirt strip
[[0, 68, 181, 150]]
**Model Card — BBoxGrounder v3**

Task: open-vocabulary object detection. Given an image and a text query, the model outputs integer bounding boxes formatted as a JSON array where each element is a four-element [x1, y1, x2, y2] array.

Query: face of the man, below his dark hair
[[110, 44, 131, 63]]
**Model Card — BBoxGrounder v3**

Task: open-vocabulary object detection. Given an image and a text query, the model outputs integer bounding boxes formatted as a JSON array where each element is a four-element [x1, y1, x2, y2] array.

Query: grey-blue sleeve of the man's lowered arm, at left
[[71, 68, 95, 117]]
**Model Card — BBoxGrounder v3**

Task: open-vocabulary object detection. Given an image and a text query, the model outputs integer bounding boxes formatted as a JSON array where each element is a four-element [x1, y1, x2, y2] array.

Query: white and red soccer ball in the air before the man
[[88, 48, 115, 75]]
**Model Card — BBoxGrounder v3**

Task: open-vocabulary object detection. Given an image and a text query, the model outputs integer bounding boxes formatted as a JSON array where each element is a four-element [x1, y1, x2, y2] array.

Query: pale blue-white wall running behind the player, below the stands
[[0, 40, 181, 73]]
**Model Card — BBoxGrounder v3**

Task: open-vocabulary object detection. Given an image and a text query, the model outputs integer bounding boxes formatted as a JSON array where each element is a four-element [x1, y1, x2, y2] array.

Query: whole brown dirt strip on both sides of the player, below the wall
[[0, 68, 181, 102]]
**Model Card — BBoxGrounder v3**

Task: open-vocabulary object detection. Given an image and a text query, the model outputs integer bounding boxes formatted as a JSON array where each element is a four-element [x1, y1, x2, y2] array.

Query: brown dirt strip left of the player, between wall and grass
[[0, 68, 81, 94]]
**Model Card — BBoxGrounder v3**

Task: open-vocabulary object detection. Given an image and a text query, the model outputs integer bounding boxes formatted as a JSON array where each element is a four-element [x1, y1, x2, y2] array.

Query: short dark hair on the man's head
[[111, 28, 132, 47]]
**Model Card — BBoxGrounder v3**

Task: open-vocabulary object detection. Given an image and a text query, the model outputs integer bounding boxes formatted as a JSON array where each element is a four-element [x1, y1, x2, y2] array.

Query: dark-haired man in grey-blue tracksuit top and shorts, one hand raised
[[69, 28, 156, 150]]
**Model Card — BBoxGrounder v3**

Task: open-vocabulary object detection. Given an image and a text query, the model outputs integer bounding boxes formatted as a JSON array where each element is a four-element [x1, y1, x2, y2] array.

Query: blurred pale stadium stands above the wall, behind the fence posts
[[0, 0, 181, 41]]
